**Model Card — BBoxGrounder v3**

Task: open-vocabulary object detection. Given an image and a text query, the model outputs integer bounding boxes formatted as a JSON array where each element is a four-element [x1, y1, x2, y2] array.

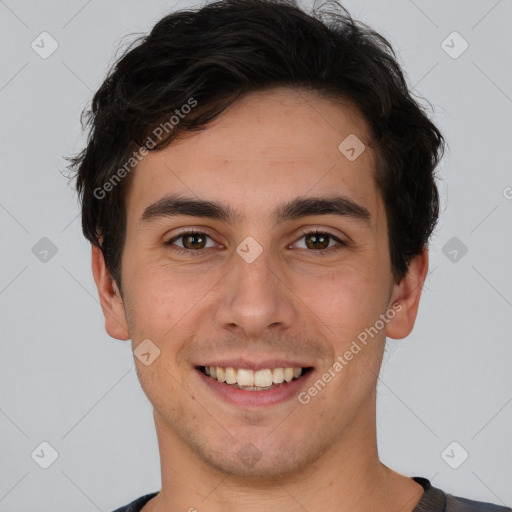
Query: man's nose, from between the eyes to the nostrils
[[215, 243, 298, 340]]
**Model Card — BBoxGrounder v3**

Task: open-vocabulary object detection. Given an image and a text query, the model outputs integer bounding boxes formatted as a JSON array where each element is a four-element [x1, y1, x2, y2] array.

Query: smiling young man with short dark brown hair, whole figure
[[69, 0, 510, 512]]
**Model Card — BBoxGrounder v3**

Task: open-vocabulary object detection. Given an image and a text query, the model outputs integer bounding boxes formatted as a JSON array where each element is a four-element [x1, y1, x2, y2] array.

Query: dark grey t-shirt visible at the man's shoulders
[[110, 476, 512, 512]]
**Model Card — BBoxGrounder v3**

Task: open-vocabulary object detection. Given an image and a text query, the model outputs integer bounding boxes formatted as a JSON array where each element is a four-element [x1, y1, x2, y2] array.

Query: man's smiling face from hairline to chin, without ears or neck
[[97, 88, 420, 477]]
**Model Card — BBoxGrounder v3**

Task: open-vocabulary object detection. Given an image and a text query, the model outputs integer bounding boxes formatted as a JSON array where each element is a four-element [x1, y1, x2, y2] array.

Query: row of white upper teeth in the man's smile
[[204, 366, 302, 388]]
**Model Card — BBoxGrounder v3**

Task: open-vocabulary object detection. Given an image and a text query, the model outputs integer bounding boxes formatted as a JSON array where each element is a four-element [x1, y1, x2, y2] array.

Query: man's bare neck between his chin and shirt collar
[[143, 400, 423, 512]]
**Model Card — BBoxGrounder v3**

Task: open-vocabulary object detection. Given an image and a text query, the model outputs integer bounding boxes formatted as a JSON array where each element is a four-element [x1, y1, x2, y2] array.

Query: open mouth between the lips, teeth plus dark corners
[[197, 366, 313, 393]]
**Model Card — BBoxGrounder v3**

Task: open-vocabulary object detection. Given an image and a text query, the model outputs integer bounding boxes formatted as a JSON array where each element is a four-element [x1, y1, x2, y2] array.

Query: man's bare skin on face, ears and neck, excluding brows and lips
[[92, 88, 428, 512]]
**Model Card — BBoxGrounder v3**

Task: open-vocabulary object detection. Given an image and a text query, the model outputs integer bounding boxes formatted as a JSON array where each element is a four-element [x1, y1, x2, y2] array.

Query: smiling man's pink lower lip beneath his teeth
[[196, 370, 313, 407]]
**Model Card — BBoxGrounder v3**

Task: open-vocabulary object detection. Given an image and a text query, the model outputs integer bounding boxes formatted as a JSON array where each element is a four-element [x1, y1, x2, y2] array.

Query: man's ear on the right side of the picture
[[386, 246, 428, 339]]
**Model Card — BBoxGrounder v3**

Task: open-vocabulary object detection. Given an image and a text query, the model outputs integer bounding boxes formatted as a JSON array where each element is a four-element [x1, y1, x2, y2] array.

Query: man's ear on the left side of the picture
[[91, 245, 130, 340]]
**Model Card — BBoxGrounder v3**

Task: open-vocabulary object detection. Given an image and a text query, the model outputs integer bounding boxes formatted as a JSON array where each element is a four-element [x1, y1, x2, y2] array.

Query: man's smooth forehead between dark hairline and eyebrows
[[123, 88, 379, 224]]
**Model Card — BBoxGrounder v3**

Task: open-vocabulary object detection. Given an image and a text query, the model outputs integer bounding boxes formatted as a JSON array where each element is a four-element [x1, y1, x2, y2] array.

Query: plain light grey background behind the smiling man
[[0, 0, 512, 512]]
